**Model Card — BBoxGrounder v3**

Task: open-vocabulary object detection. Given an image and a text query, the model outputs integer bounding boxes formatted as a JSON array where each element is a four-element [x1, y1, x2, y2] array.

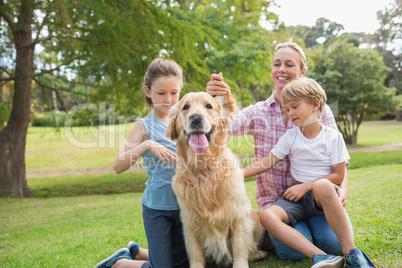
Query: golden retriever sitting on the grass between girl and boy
[[166, 92, 266, 268]]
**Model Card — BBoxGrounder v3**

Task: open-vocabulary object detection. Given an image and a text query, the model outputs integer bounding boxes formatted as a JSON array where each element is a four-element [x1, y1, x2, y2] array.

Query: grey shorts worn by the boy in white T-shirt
[[272, 182, 338, 227]]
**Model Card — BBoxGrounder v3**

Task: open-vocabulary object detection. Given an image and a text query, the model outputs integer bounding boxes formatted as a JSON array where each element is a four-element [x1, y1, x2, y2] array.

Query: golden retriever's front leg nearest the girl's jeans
[[183, 224, 205, 268]]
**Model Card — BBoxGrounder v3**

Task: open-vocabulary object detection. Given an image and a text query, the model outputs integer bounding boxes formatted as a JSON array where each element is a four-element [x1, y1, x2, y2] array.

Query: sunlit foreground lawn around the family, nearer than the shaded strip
[[0, 165, 402, 268]]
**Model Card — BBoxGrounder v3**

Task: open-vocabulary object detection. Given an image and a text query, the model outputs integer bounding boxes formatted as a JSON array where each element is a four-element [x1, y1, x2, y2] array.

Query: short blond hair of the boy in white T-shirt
[[280, 77, 327, 113]]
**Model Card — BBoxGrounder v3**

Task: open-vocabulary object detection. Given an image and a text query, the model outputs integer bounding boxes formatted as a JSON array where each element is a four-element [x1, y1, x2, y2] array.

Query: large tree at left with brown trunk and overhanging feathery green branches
[[0, 0, 207, 196]]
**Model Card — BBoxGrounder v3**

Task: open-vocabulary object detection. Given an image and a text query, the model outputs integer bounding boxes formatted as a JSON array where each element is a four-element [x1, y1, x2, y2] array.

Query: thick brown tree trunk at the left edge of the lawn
[[0, 0, 34, 197]]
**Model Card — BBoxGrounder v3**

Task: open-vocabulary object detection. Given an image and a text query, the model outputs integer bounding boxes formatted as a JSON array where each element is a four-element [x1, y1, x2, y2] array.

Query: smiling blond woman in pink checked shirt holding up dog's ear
[[207, 43, 352, 260]]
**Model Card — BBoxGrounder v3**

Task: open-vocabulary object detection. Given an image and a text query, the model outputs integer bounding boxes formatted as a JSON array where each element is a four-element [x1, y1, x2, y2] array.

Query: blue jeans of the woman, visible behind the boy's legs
[[268, 211, 353, 261]]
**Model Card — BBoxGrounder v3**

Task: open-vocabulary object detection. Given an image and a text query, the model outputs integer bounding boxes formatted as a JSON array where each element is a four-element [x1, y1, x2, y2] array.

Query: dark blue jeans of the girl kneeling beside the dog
[[141, 206, 190, 268]]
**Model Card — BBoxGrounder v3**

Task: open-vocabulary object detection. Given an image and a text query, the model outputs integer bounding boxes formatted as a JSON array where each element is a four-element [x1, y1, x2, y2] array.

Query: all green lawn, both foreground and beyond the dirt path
[[0, 121, 402, 268]]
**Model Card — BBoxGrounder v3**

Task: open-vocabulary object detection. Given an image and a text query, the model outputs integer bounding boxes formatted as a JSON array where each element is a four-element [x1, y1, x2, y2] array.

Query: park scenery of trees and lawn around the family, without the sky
[[0, 0, 402, 267]]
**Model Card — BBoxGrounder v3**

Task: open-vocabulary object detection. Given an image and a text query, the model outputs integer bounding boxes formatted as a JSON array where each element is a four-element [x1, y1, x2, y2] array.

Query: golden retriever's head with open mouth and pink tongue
[[166, 92, 236, 155]]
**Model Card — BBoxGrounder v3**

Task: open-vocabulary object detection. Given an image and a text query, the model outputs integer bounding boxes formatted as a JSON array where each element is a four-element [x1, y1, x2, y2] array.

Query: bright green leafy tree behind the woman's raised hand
[[200, 1, 277, 106]]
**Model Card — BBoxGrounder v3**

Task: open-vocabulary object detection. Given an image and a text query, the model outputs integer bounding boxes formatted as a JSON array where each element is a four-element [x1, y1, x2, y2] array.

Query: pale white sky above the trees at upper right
[[268, 0, 394, 33]]
